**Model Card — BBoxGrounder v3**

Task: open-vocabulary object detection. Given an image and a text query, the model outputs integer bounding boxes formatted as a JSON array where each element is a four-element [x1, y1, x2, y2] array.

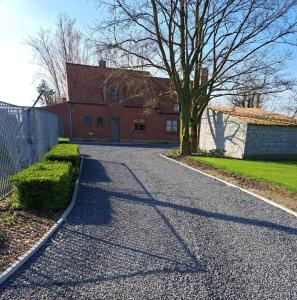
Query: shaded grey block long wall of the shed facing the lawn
[[244, 125, 297, 157]]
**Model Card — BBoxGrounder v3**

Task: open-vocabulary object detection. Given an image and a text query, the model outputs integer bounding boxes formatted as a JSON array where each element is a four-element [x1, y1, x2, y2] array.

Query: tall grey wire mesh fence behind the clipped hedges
[[0, 101, 58, 199]]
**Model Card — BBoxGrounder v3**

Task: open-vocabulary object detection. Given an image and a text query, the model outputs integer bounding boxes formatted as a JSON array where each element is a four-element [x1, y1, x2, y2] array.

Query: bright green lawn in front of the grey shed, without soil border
[[191, 157, 297, 193]]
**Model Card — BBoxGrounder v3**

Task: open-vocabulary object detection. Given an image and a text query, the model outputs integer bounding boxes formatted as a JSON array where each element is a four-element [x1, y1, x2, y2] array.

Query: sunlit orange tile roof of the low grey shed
[[208, 106, 297, 126]]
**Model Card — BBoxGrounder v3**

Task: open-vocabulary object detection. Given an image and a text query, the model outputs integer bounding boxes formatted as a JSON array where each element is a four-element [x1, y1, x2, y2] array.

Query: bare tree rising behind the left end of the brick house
[[26, 14, 91, 101]]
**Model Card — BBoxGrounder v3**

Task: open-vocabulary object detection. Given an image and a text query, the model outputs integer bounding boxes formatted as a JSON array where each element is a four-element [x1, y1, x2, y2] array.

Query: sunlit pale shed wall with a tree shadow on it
[[199, 109, 247, 158]]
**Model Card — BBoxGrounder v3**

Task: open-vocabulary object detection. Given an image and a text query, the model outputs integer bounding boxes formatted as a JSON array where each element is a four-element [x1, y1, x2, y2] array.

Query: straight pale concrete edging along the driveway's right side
[[159, 153, 297, 217]]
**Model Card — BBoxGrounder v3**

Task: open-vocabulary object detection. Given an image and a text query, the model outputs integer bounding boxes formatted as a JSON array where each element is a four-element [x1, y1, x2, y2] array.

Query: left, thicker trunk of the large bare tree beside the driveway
[[179, 93, 191, 155]]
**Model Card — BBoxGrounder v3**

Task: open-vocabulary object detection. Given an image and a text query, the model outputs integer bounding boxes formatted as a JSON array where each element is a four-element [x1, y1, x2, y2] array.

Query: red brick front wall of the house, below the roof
[[45, 103, 179, 142]]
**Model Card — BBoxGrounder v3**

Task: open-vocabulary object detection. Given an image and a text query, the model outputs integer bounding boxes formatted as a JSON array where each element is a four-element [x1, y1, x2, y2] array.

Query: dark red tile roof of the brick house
[[65, 61, 172, 106]]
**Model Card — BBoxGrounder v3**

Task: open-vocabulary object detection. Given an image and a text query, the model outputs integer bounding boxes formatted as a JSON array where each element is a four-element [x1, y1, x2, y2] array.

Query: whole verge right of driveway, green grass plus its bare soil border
[[166, 151, 297, 212]]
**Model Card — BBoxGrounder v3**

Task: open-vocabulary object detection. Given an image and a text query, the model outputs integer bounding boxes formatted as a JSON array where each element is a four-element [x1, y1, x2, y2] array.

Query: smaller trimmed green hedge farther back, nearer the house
[[44, 144, 79, 171]]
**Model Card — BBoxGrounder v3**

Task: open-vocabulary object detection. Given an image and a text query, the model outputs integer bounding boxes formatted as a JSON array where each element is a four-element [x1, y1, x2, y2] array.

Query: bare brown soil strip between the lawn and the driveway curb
[[167, 155, 297, 212]]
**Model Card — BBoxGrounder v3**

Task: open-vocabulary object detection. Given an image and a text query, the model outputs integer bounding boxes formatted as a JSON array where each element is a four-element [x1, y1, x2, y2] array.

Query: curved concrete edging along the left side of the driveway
[[0, 156, 84, 285]]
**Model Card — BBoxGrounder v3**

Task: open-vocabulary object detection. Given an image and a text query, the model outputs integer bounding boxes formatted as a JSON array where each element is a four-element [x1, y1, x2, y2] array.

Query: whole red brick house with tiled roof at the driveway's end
[[45, 62, 179, 142]]
